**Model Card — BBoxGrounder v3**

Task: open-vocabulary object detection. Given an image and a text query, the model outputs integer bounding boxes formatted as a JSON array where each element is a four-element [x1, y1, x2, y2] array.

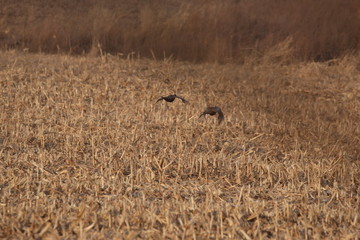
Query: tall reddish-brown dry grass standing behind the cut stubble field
[[0, 0, 360, 63]]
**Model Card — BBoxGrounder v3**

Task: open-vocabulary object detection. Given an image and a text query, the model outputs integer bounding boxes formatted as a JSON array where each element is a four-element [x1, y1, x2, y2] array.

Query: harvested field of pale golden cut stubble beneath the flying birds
[[0, 51, 360, 239]]
